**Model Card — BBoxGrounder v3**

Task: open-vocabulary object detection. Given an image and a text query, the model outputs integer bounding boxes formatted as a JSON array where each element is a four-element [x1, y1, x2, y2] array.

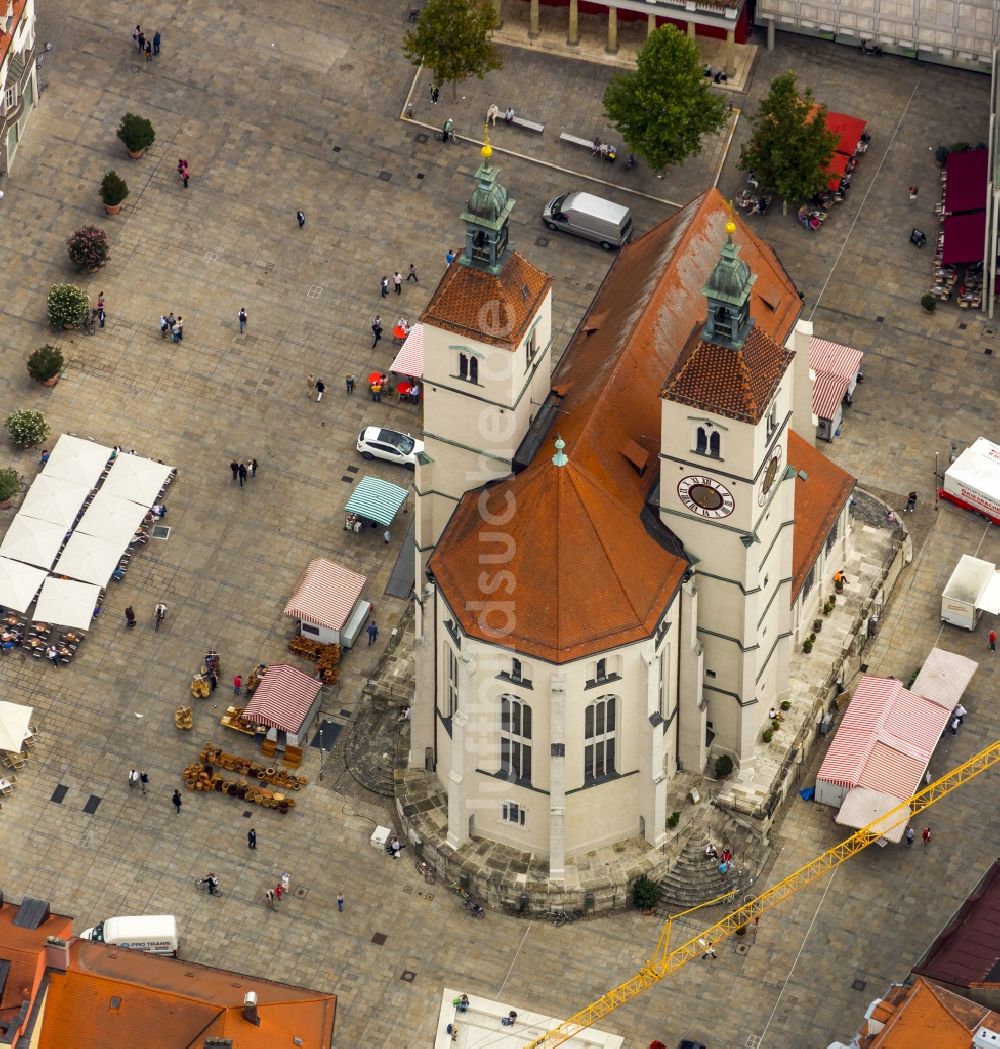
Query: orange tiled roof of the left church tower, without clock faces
[[420, 252, 552, 349]]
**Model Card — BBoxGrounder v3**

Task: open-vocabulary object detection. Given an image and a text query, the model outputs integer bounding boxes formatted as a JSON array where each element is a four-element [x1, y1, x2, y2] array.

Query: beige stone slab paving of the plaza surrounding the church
[[0, 0, 1000, 1049]]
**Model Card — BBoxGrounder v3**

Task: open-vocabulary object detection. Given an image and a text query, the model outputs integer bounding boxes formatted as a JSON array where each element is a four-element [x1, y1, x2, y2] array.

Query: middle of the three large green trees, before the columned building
[[604, 25, 726, 170]]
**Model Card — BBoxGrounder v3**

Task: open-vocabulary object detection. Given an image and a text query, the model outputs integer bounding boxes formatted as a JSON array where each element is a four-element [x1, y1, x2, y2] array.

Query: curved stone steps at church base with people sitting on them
[[660, 806, 770, 914]]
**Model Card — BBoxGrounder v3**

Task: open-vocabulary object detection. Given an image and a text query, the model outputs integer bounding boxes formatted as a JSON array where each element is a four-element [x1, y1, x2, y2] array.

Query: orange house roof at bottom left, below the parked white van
[[38, 940, 336, 1049]]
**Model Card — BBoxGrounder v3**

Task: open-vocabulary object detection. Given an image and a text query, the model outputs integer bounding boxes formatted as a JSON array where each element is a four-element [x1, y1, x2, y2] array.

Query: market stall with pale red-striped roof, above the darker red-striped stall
[[284, 557, 371, 648]]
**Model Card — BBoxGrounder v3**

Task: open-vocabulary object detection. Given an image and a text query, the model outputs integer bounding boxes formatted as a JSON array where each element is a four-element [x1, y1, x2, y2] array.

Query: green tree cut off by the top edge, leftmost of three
[[403, 0, 504, 98]]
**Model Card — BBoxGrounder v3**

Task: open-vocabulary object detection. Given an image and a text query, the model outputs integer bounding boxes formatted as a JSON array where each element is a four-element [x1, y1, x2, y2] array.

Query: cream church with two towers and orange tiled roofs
[[410, 137, 854, 884]]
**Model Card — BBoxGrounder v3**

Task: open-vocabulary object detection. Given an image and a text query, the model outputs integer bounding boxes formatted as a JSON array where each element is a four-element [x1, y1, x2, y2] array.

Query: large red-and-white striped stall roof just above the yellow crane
[[816, 678, 951, 800]]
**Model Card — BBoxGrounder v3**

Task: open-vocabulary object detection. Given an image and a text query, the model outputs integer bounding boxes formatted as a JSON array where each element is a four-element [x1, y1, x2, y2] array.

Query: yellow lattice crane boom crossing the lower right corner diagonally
[[528, 741, 1000, 1049]]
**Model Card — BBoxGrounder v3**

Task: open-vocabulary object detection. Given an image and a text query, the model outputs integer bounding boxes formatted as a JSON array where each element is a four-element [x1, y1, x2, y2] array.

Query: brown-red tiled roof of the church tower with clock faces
[[660, 327, 795, 425]]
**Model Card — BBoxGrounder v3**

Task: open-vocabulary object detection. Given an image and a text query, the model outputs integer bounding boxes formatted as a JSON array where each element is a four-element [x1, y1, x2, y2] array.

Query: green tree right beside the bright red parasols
[[740, 70, 838, 205]]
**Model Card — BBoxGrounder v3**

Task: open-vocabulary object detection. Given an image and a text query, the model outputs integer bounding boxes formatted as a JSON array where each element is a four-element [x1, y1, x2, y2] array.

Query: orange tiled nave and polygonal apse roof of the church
[[432, 190, 801, 662]]
